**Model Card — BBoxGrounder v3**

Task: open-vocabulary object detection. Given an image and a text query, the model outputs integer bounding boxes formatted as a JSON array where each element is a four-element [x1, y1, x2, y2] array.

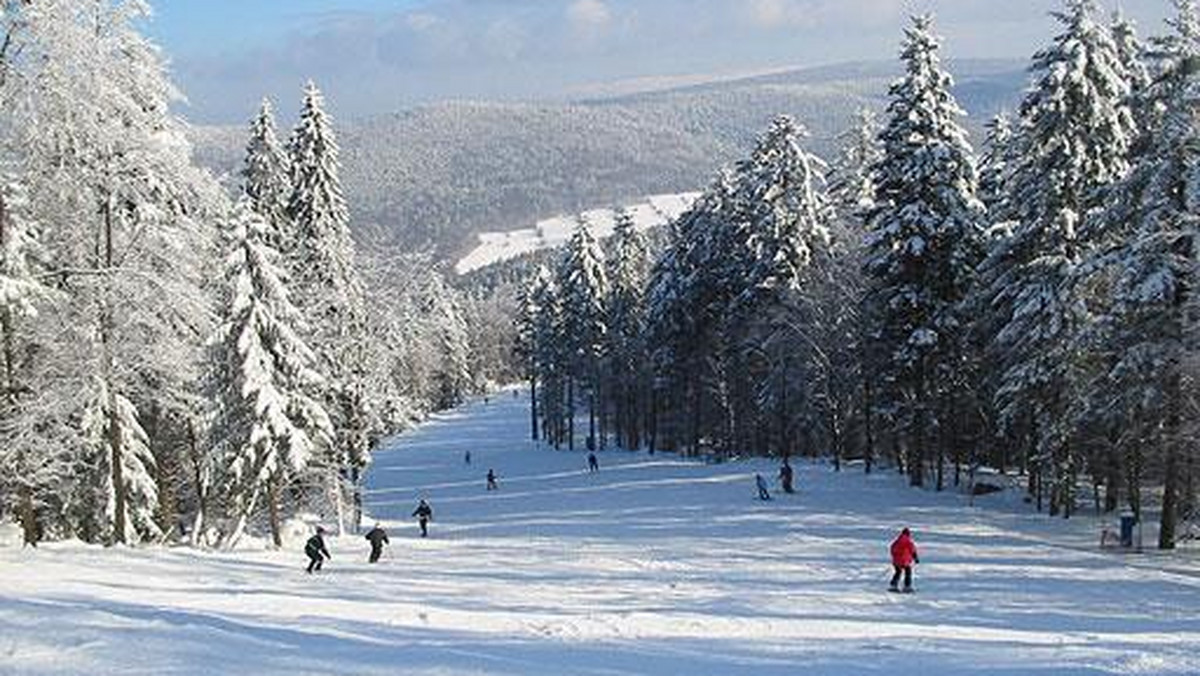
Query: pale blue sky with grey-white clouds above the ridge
[[150, 0, 1170, 122]]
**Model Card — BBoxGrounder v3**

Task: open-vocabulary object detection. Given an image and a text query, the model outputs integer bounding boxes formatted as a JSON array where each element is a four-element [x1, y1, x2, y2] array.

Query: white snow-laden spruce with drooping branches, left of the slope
[[206, 197, 332, 546]]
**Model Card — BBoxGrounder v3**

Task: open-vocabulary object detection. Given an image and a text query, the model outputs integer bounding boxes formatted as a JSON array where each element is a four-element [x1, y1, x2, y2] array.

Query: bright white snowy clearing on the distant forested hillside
[[455, 192, 700, 275]]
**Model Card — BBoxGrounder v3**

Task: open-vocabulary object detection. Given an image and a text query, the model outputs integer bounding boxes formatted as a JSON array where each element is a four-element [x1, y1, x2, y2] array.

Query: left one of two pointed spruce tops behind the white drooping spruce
[[241, 98, 294, 251]]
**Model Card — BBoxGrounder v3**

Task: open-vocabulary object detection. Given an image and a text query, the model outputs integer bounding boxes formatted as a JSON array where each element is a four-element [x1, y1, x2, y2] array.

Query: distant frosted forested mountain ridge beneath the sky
[[192, 60, 1027, 261]]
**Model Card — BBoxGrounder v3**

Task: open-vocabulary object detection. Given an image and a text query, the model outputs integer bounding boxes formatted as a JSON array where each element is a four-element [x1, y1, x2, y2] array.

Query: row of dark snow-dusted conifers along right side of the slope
[[520, 0, 1200, 548]]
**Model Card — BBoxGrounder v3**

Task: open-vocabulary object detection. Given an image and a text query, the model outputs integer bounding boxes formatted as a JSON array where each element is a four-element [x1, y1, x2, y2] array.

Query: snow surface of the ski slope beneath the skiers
[[0, 395, 1200, 676]]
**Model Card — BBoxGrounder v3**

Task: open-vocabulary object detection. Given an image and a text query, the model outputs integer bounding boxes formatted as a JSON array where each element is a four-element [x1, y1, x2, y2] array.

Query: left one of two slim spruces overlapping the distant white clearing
[[556, 213, 608, 448]]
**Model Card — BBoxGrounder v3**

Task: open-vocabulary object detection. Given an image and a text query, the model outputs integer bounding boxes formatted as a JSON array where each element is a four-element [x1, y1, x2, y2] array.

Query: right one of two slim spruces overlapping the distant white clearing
[[607, 210, 649, 450]]
